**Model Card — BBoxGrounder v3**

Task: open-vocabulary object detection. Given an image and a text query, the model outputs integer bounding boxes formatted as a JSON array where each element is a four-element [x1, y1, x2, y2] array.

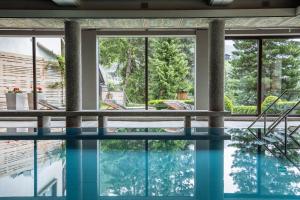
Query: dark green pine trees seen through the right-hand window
[[226, 39, 300, 105]]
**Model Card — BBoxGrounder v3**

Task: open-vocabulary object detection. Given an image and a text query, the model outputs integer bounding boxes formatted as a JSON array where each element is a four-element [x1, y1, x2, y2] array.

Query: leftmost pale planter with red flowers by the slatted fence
[[5, 87, 26, 110]]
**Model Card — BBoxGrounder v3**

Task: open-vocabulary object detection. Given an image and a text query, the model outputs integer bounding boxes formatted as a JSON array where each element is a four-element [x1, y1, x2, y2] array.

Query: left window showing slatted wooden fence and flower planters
[[0, 37, 64, 110]]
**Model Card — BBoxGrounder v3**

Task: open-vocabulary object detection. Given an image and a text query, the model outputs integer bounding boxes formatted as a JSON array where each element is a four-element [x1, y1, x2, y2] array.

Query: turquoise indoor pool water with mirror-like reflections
[[0, 129, 300, 200]]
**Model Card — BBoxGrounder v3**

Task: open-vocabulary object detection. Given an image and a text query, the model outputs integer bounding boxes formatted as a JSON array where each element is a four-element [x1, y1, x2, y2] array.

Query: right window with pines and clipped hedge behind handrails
[[225, 38, 300, 115]]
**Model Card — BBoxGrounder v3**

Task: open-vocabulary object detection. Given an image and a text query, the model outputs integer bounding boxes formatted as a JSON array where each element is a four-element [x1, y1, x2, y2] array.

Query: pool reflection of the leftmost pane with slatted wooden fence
[[0, 140, 34, 197]]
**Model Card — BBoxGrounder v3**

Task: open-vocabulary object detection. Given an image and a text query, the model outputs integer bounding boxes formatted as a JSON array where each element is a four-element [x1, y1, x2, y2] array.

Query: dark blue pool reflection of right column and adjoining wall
[[195, 128, 224, 200]]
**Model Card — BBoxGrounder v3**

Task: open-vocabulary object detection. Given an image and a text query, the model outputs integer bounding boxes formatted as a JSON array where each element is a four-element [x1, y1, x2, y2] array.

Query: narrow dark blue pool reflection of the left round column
[[66, 140, 82, 200]]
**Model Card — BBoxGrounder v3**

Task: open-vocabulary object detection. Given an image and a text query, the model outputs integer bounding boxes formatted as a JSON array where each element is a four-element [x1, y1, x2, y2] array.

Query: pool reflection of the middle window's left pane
[[99, 140, 146, 196]]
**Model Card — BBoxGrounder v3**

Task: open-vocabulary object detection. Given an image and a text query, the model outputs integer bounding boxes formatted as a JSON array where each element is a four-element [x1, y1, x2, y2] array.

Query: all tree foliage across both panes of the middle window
[[99, 38, 194, 103]]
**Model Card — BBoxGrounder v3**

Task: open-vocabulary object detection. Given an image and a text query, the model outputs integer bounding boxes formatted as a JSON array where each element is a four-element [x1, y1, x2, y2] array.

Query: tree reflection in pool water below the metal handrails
[[229, 129, 300, 194]]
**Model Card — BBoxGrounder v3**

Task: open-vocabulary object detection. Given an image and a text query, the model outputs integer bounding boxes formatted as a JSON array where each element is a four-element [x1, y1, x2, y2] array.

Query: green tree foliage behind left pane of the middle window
[[99, 38, 145, 103]]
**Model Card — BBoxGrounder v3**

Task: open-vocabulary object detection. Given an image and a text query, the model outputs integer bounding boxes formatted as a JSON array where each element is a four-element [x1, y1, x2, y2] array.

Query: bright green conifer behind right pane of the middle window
[[149, 38, 192, 99]]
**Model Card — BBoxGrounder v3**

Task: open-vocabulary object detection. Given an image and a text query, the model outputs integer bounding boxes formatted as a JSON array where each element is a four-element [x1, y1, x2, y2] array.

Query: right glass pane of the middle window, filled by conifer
[[148, 37, 195, 110]]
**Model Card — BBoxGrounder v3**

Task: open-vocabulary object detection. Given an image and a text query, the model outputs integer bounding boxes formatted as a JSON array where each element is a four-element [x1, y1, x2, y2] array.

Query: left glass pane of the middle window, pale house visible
[[98, 37, 145, 110]]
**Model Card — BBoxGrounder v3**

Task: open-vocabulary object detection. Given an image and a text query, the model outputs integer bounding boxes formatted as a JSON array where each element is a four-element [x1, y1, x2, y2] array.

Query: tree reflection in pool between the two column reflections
[[100, 140, 194, 196]]
